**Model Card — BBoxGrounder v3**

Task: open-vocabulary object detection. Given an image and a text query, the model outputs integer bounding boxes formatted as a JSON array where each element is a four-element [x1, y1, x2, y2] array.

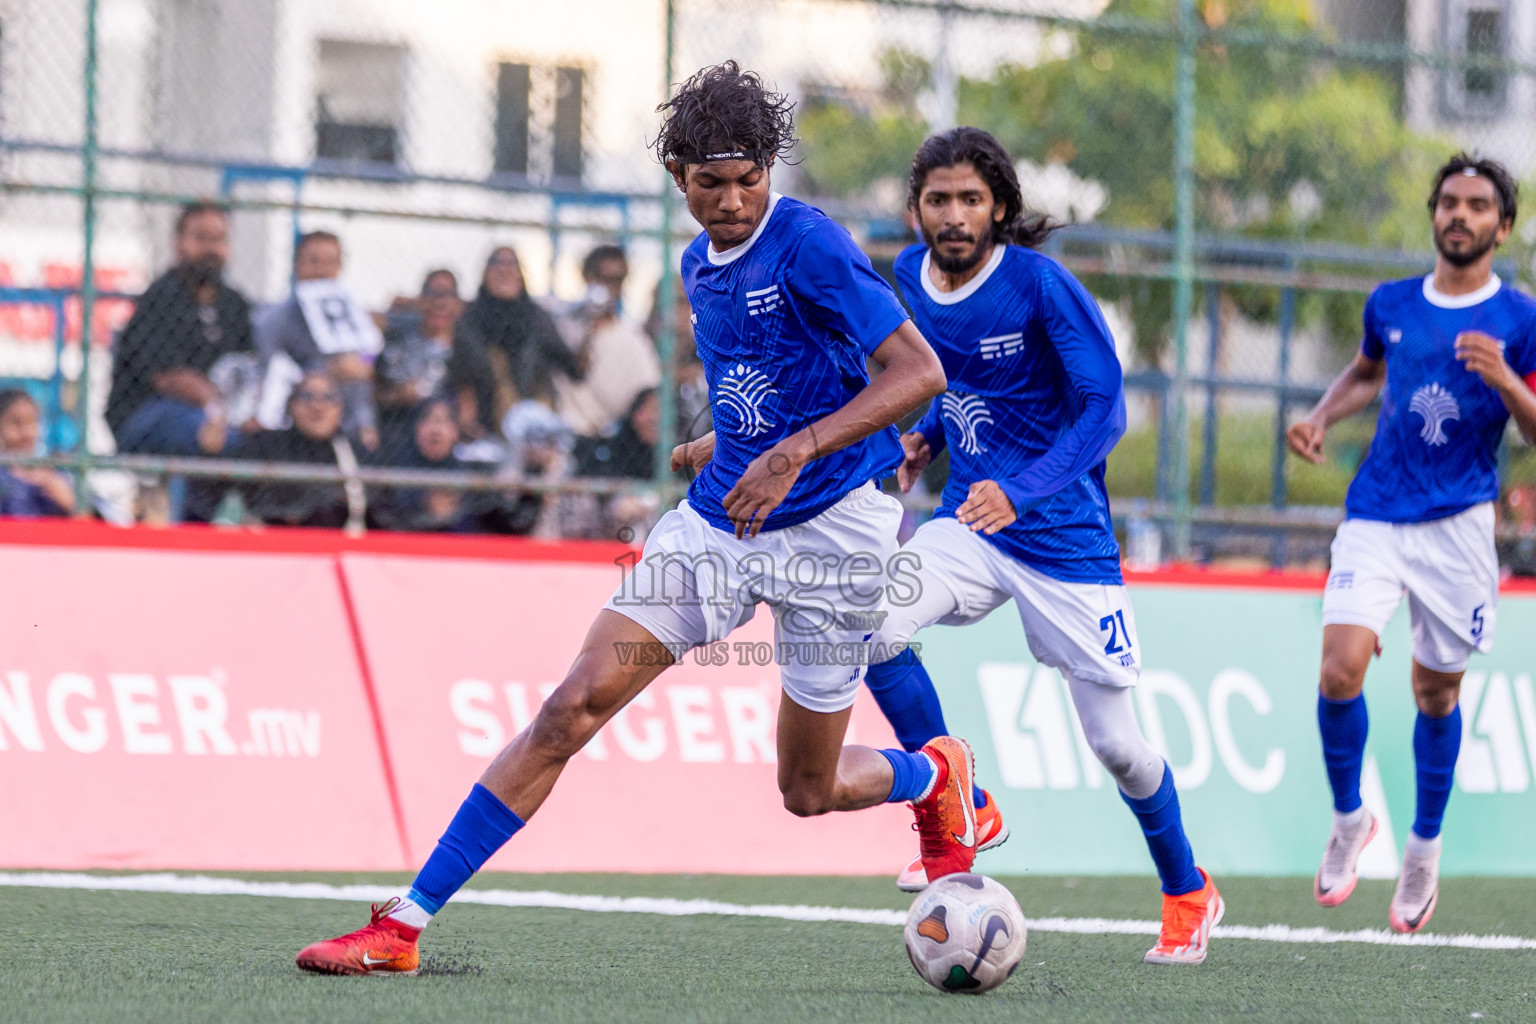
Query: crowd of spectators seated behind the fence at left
[[19, 196, 710, 536]]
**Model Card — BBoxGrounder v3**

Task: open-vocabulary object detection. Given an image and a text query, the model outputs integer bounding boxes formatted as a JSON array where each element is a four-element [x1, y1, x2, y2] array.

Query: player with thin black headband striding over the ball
[[298, 61, 975, 975]]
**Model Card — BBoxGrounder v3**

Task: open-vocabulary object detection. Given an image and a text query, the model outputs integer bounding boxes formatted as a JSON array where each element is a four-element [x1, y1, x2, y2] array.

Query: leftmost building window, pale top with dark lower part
[[315, 40, 406, 166]]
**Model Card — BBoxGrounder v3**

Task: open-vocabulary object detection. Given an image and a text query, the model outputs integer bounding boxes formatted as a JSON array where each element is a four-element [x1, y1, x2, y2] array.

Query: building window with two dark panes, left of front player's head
[[492, 63, 587, 184]]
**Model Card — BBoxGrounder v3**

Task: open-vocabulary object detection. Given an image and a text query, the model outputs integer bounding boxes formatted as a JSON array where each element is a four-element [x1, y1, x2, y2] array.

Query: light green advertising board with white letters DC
[[917, 583, 1536, 878]]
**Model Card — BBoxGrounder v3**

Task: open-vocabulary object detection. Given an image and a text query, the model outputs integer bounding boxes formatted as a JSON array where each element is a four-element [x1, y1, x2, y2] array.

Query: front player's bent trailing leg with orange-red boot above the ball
[[779, 694, 975, 878]]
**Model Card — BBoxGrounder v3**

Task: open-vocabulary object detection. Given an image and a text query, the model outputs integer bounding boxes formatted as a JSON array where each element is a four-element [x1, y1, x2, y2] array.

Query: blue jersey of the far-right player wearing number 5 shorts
[[1344, 276, 1536, 522]]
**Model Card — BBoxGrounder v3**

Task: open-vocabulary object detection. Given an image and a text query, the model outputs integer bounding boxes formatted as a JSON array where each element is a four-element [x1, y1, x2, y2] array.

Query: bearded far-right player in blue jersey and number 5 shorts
[[1287, 154, 1536, 932]]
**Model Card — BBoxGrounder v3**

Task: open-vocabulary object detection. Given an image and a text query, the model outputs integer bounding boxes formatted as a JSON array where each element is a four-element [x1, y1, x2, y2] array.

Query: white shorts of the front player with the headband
[[605, 484, 902, 712]]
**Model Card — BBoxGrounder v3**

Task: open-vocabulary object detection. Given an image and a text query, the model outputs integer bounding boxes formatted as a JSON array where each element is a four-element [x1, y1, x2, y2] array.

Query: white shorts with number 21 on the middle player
[[876, 516, 1141, 686]]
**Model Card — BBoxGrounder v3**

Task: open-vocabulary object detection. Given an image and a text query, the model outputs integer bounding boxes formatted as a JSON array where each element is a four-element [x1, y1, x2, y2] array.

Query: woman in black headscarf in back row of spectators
[[449, 246, 585, 436]]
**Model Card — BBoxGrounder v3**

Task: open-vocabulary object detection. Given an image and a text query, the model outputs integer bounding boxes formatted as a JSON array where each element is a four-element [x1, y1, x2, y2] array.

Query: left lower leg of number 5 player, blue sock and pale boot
[[1312, 623, 1378, 907]]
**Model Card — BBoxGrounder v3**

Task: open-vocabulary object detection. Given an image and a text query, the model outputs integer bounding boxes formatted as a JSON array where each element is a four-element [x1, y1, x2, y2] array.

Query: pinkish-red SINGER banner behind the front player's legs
[[341, 554, 917, 874]]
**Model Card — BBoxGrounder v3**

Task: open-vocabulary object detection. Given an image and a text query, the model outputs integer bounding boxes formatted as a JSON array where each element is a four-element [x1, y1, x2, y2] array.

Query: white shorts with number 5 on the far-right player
[[1322, 502, 1499, 672]]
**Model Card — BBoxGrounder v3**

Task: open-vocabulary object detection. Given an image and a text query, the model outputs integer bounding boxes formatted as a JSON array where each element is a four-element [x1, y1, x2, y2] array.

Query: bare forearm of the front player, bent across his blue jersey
[[723, 321, 946, 537]]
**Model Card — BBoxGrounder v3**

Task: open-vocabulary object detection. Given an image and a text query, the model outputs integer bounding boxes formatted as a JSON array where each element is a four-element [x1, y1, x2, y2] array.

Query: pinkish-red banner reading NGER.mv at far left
[[0, 545, 406, 870]]
